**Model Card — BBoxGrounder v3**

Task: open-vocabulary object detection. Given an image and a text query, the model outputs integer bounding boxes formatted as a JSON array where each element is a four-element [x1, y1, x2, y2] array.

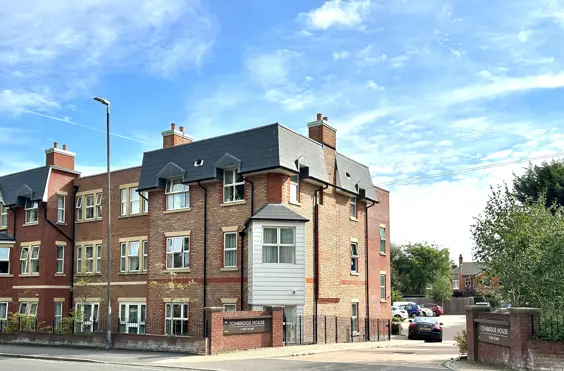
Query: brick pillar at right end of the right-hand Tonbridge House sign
[[509, 308, 540, 368]]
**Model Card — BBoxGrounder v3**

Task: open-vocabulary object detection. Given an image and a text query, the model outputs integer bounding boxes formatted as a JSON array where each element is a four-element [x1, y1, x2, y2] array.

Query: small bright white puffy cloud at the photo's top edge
[[299, 0, 371, 30]]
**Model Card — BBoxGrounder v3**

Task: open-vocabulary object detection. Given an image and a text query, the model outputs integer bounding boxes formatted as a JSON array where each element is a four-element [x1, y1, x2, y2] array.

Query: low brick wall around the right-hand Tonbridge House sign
[[466, 305, 564, 371]]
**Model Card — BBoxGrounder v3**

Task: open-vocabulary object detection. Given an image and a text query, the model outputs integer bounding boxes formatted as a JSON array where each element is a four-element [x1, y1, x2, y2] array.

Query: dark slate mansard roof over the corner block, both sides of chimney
[[139, 123, 377, 201]]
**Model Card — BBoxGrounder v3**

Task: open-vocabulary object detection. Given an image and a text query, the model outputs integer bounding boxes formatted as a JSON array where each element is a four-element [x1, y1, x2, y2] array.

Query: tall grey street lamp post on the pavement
[[94, 97, 112, 350]]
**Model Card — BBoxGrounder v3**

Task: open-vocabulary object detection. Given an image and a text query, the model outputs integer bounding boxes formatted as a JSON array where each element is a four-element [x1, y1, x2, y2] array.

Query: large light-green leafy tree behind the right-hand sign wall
[[471, 185, 564, 310]]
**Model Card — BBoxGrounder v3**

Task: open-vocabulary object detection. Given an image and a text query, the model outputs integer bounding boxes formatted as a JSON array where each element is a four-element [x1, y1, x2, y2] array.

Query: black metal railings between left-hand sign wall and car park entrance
[[283, 315, 391, 345]]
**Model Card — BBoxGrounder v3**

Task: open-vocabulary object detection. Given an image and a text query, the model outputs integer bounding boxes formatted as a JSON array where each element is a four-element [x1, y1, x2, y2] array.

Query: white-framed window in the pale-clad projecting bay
[[262, 227, 296, 264]]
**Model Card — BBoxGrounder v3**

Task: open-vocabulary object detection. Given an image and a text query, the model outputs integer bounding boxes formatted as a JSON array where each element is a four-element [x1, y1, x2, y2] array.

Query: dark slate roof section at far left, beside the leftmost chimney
[[0, 166, 50, 206]]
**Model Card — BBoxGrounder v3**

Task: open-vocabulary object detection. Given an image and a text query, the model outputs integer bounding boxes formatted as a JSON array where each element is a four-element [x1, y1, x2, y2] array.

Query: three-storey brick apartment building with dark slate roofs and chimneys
[[0, 114, 390, 334]]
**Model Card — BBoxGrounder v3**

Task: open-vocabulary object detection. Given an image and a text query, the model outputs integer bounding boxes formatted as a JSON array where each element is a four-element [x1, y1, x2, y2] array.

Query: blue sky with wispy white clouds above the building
[[0, 0, 564, 259]]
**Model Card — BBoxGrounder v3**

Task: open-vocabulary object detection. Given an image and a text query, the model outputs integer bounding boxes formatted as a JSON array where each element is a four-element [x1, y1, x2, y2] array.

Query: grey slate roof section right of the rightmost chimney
[[336, 152, 378, 202]]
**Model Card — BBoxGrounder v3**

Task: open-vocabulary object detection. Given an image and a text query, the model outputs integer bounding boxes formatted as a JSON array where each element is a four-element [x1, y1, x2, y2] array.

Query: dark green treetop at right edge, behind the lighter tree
[[513, 160, 564, 207]]
